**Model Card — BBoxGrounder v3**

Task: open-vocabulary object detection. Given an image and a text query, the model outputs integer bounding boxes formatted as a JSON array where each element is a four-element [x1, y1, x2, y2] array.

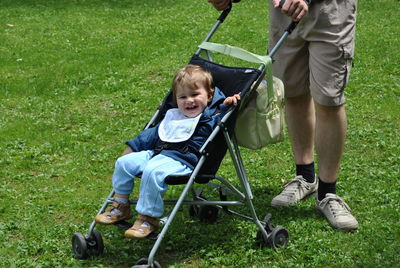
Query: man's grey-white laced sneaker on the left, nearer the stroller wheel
[[271, 176, 318, 207]]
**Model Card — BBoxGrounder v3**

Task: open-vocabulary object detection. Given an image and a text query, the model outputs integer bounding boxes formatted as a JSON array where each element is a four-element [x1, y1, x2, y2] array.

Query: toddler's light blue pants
[[112, 151, 192, 218]]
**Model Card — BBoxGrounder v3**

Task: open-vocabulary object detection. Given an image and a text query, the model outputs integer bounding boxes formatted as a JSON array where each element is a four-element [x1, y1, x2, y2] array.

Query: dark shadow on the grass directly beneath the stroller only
[[76, 211, 245, 267]]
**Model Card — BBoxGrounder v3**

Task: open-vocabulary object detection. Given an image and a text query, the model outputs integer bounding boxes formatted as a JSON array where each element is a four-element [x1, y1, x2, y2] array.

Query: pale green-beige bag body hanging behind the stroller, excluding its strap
[[235, 77, 285, 150]]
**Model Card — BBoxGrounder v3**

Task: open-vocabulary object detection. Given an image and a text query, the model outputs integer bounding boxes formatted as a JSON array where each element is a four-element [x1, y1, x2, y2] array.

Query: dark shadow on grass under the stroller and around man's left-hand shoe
[[76, 187, 324, 267]]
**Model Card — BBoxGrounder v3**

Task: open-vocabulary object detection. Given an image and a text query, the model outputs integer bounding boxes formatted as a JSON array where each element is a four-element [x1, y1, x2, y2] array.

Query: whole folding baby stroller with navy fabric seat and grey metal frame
[[72, 4, 291, 267]]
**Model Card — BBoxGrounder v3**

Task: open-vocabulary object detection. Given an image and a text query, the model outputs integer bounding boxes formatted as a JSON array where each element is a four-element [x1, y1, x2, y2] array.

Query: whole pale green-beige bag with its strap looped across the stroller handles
[[199, 42, 285, 150]]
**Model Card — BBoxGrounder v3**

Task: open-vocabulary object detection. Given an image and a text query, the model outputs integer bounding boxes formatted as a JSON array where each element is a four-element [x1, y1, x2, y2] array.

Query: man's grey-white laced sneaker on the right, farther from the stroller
[[317, 194, 358, 231]]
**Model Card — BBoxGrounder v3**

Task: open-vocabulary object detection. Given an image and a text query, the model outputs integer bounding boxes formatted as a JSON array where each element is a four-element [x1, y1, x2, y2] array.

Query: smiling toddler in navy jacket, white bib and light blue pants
[[95, 65, 240, 239]]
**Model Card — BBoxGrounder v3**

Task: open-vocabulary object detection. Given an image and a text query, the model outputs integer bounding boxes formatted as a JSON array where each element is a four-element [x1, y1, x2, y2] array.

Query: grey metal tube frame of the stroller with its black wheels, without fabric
[[72, 5, 296, 267]]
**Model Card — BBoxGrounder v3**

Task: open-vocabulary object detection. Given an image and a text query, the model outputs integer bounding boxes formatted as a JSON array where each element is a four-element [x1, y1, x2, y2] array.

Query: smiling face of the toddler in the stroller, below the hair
[[176, 86, 212, 118]]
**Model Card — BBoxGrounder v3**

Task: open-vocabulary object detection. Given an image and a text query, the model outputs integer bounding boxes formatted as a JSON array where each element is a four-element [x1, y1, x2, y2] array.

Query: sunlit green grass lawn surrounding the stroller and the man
[[0, 0, 400, 267]]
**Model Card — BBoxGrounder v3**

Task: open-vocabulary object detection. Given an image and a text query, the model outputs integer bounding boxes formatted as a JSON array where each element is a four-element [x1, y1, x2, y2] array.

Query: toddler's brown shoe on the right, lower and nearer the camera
[[125, 214, 160, 239]]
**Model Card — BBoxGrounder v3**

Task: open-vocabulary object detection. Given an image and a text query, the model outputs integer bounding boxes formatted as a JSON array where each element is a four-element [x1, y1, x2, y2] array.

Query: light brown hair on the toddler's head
[[172, 64, 214, 103]]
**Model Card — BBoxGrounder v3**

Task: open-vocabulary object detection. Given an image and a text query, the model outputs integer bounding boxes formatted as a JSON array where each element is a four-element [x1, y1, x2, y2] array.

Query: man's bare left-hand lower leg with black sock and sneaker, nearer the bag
[[271, 93, 317, 207]]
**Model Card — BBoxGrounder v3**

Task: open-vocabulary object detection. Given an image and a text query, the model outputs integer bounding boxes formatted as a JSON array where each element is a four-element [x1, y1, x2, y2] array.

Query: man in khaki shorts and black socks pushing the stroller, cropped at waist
[[208, 0, 358, 230]]
